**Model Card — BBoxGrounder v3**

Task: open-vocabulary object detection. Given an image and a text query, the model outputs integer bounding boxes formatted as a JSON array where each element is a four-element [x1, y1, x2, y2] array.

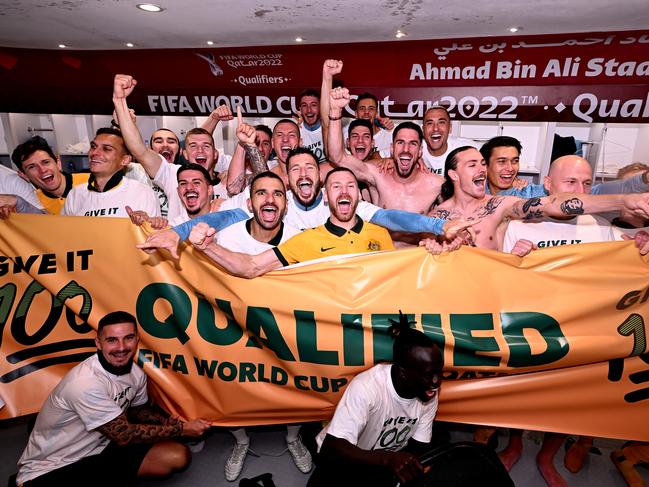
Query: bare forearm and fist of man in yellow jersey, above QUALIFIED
[[189, 223, 282, 279]]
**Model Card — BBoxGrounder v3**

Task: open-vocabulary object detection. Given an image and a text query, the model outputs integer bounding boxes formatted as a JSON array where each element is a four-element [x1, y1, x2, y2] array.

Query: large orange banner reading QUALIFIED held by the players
[[0, 215, 649, 440]]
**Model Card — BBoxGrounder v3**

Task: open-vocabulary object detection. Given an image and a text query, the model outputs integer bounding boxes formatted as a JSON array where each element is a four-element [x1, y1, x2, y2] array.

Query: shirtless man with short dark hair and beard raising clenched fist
[[328, 88, 443, 214]]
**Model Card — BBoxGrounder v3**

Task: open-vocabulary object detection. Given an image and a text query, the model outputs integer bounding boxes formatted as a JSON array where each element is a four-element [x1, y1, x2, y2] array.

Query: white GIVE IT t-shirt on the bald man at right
[[503, 215, 615, 253]]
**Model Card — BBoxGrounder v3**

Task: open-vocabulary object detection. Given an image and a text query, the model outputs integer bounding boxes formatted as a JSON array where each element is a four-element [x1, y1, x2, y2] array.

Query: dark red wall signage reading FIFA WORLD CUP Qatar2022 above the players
[[0, 31, 649, 123]]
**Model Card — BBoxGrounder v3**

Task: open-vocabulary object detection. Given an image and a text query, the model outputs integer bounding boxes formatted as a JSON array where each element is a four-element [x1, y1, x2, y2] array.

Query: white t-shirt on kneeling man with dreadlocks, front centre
[[316, 364, 439, 451]]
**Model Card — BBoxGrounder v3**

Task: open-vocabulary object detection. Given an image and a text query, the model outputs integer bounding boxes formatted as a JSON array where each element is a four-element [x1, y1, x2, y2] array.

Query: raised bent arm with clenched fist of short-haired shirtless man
[[327, 88, 376, 186]]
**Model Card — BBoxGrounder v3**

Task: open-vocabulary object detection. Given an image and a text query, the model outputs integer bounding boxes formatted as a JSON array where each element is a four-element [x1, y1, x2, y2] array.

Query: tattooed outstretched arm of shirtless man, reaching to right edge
[[504, 193, 649, 220]]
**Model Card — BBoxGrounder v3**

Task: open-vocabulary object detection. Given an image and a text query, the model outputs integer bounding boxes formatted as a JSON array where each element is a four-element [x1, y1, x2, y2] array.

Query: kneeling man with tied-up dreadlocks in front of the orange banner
[[308, 315, 442, 487]]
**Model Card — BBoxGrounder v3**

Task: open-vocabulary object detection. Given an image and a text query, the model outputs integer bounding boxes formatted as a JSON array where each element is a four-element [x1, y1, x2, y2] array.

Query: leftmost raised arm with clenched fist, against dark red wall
[[113, 74, 162, 178]]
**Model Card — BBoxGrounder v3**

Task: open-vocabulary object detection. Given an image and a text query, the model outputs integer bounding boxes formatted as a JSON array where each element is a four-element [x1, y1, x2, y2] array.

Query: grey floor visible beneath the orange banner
[[0, 418, 649, 487]]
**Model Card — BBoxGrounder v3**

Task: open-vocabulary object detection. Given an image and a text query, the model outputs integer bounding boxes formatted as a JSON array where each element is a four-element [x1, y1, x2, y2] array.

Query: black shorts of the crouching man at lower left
[[23, 443, 153, 487]]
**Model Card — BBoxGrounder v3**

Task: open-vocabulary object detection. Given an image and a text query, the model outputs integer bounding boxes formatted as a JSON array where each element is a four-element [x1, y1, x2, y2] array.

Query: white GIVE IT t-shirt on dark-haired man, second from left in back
[[61, 173, 160, 218]]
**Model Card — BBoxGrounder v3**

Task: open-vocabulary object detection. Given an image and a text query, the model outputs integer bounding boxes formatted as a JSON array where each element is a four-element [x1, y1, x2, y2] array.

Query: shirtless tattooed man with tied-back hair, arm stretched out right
[[431, 146, 649, 250]]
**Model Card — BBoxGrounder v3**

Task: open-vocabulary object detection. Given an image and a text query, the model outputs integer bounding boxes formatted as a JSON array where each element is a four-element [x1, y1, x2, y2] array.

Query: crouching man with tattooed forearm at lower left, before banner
[[17, 311, 210, 487]]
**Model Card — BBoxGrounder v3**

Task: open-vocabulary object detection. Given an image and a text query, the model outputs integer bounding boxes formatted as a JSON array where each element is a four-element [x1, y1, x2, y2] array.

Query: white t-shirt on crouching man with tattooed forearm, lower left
[[17, 354, 148, 484]]
